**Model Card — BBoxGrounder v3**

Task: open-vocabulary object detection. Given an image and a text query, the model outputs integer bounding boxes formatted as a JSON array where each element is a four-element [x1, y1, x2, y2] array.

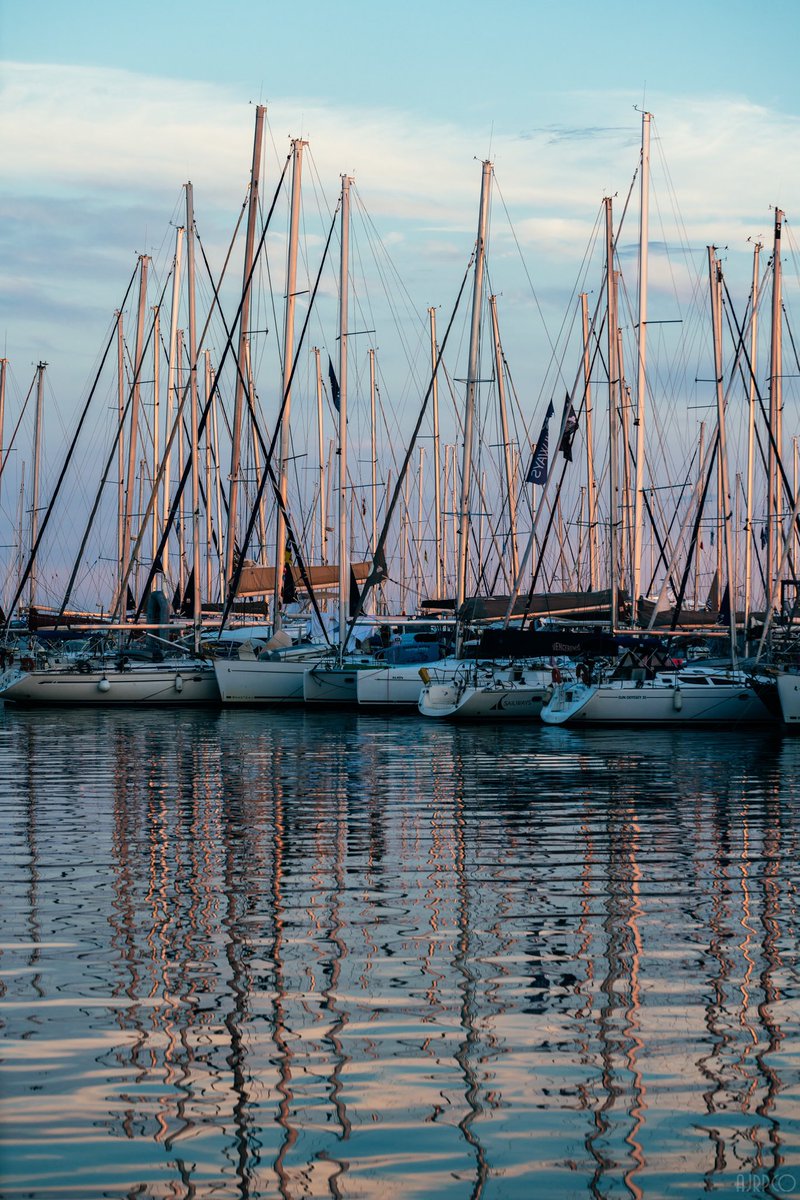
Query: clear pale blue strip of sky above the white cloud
[[7, 0, 799, 119]]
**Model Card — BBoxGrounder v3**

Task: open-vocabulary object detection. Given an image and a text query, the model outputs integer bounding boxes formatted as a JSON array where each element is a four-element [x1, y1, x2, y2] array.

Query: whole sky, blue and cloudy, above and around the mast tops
[[0, 0, 800, 609]]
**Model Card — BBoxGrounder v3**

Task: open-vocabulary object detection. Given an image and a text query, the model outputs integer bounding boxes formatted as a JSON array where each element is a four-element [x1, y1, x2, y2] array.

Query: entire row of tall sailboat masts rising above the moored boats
[[0, 107, 796, 634]]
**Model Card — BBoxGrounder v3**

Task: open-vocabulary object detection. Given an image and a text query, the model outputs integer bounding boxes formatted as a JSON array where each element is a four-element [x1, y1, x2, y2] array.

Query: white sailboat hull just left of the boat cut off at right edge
[[541, 676, 772, 726]]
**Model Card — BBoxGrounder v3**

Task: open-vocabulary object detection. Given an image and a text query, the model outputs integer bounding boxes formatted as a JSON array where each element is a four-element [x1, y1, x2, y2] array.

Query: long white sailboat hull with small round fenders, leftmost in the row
[[0, 662, 219, 707]]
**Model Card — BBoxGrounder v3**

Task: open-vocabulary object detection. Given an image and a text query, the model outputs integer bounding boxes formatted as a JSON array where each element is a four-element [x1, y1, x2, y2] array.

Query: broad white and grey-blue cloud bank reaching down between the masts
[[0, 62, 800, 609]]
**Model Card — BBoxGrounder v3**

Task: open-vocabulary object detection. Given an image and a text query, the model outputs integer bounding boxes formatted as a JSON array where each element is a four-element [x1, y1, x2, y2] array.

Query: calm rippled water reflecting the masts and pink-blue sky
[[0, 707, 800, 1200]]
